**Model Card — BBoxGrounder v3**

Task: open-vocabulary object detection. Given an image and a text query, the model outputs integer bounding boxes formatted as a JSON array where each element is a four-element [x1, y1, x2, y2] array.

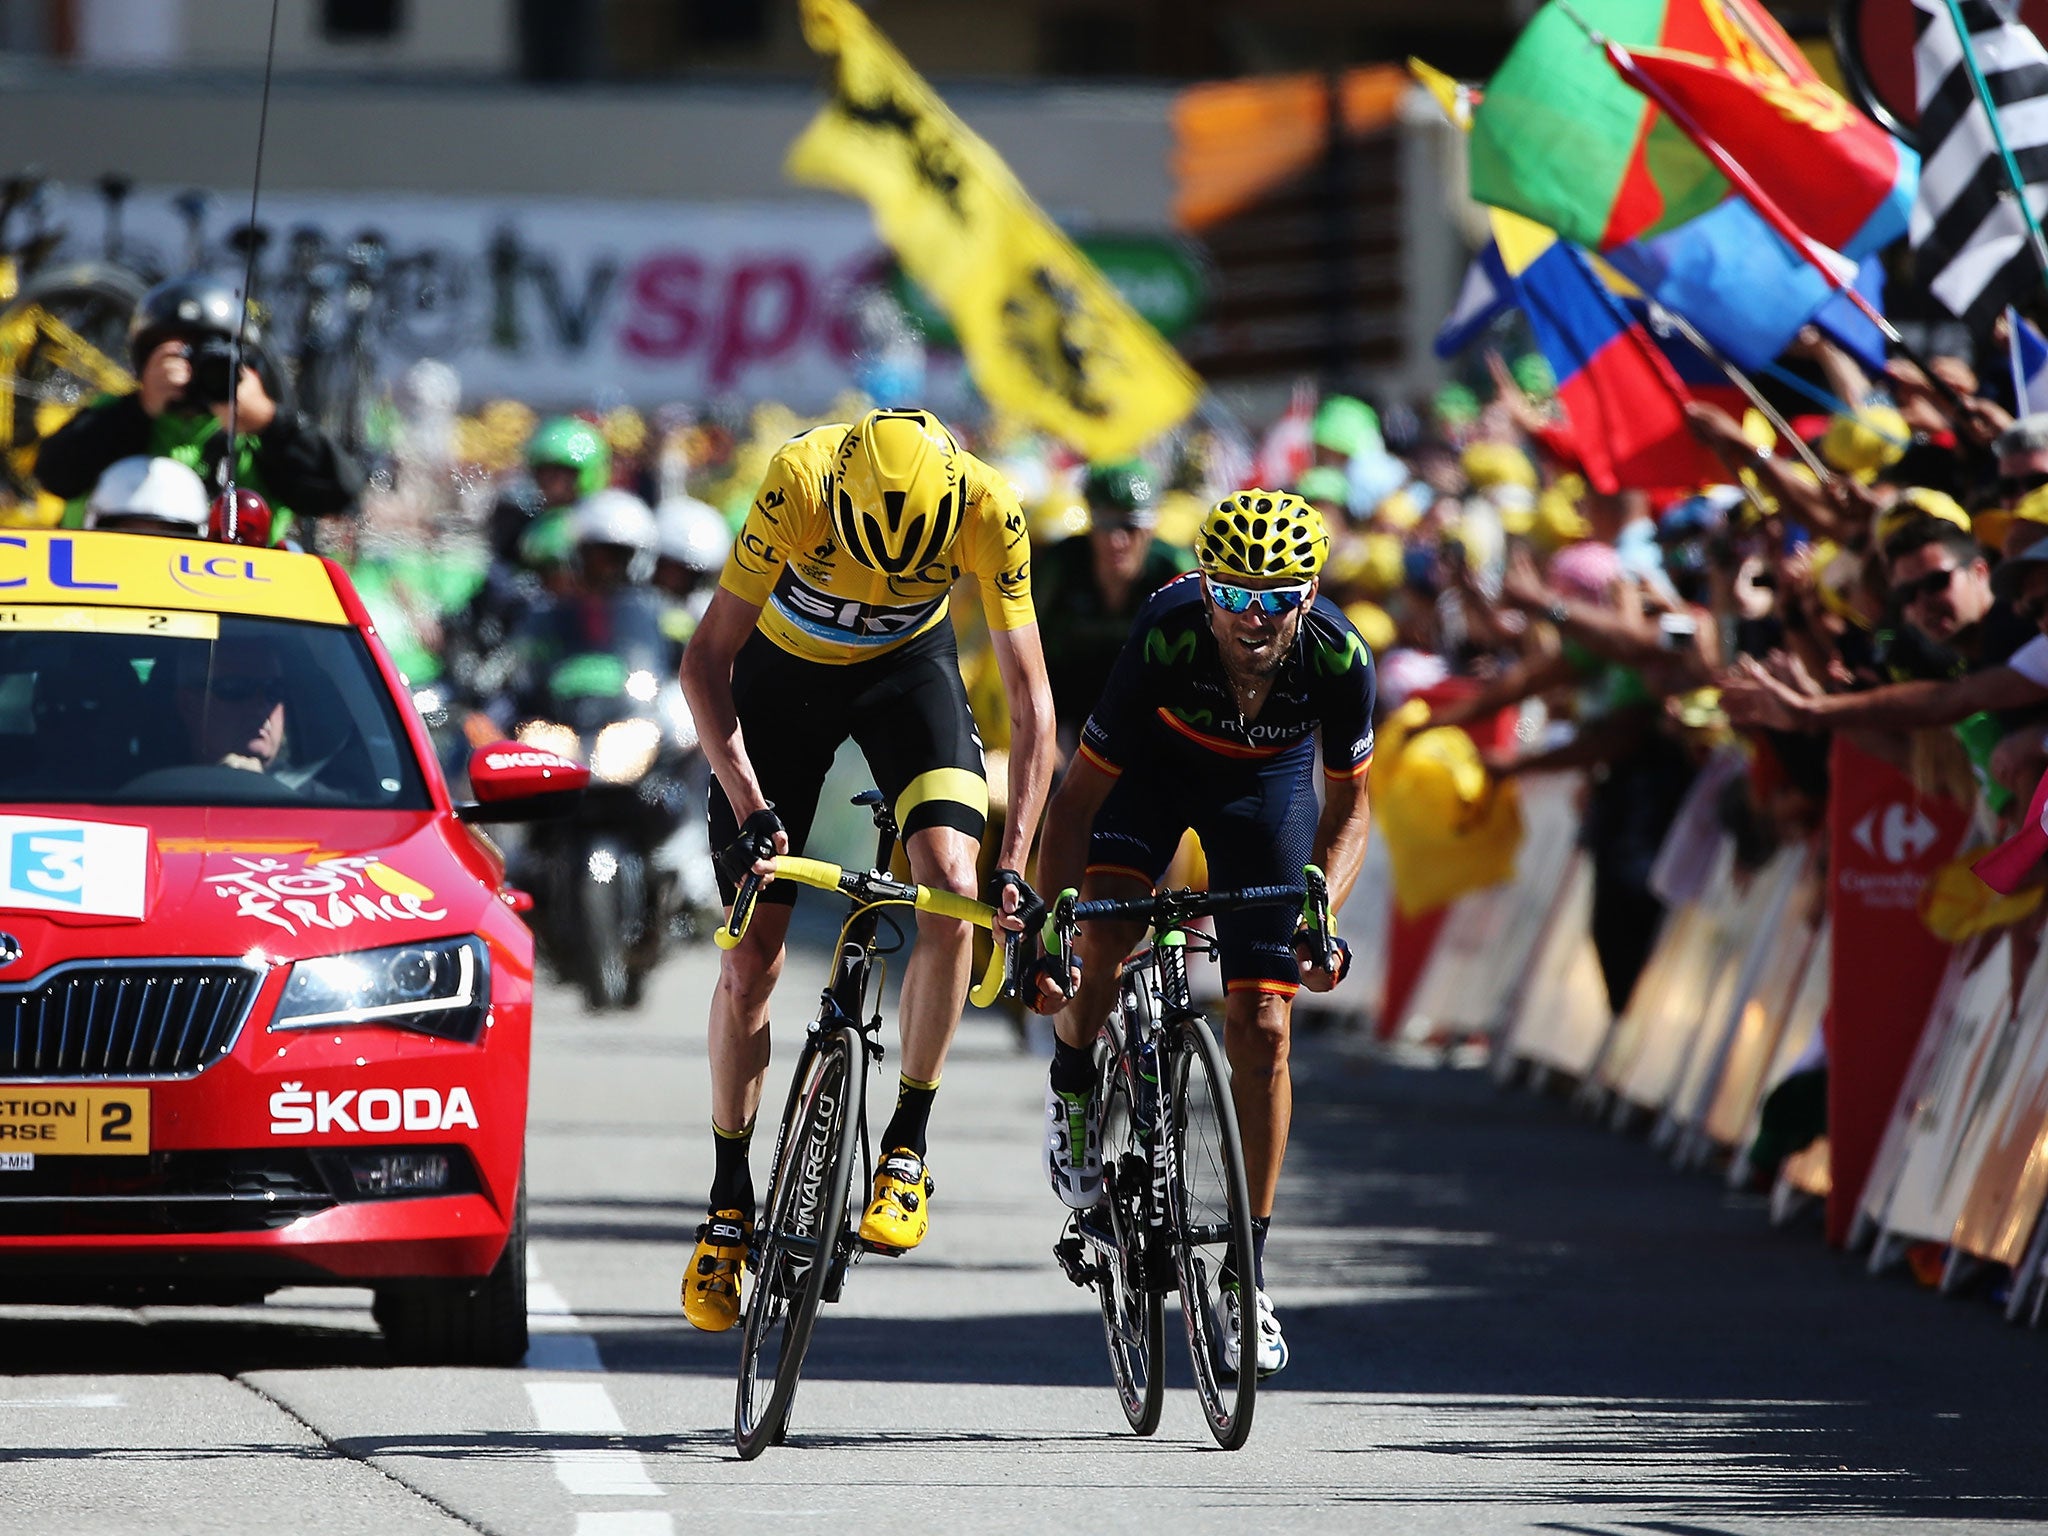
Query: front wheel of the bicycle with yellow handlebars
[[733, 1024, 866, 1460]]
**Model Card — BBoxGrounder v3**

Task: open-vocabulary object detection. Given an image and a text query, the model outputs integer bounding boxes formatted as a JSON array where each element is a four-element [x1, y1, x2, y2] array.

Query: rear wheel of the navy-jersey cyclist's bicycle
[[1096, 1015, 1165, 1436]]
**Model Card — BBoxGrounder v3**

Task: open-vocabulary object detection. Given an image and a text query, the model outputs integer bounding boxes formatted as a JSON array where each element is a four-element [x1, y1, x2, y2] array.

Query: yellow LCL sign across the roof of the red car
[[0, 528, 348, 625]]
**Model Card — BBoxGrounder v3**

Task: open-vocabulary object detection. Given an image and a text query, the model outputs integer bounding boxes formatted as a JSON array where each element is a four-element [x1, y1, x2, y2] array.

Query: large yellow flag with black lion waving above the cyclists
[[784, 0, 1202, 461]]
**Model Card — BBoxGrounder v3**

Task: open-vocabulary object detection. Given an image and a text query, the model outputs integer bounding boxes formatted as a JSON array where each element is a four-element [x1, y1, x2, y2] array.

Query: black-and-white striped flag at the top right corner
[[1913, 0, 2048, 328]]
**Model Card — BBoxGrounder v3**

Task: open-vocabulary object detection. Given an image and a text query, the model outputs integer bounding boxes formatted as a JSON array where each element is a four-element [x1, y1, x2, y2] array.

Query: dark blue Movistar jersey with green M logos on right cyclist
[[1081, 575, 1376, 778]]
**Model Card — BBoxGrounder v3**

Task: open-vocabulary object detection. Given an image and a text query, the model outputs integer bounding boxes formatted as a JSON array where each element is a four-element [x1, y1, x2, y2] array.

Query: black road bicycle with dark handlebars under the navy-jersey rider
[[1047, 864, 1337, 1450]]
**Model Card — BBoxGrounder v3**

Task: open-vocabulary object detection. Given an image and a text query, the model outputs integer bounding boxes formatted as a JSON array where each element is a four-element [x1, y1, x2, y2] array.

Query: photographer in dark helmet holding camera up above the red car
[[35, 276, 362, 539]]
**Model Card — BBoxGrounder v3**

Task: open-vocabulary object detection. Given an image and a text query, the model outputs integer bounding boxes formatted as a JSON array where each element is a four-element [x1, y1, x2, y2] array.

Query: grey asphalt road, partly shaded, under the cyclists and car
[[0, 950, 2048, 1536]]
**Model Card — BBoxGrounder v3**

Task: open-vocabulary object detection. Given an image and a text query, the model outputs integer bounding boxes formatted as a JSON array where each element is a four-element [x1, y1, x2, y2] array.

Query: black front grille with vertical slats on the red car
[[0, 961, 262, 1079]]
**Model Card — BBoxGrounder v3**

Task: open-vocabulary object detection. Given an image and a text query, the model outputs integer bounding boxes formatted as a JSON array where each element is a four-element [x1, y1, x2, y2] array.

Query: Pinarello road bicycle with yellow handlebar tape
[[713, 788, 1020, 1460]]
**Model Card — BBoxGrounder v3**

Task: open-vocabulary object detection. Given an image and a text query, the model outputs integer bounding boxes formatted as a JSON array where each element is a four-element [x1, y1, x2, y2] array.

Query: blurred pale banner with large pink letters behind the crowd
[[25, 188, 889, 410]]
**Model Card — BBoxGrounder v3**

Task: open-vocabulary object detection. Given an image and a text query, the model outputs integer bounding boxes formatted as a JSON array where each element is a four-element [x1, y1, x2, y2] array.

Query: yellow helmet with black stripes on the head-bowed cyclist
[[831, 410, 967, 575]]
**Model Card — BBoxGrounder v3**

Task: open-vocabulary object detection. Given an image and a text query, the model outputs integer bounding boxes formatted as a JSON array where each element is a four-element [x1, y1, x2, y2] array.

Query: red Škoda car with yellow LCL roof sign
[[0, 530, 584, 1362]]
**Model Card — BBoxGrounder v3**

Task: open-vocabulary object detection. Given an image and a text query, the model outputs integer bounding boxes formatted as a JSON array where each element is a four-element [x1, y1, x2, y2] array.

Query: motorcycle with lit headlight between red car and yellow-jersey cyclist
[[514, 596, 702, 1012]]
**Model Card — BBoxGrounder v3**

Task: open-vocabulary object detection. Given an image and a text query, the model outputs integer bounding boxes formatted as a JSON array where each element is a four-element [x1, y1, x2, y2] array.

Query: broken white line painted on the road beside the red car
[[526, 1249, 674, 1507]]
